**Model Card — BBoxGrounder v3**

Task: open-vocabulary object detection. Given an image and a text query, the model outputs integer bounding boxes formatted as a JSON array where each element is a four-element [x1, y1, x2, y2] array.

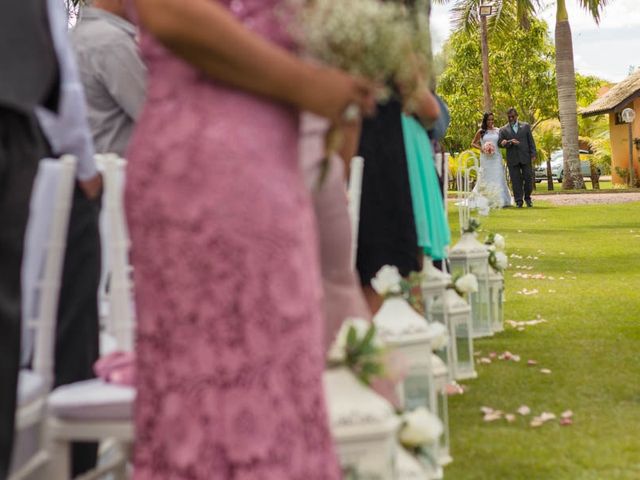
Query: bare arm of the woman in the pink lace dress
[[136, 0, 375, 120]]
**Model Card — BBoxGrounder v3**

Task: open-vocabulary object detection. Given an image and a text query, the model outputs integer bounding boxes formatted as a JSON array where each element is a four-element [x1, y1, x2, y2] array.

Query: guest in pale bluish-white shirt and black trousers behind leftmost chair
[[37, 0, 102, 476]]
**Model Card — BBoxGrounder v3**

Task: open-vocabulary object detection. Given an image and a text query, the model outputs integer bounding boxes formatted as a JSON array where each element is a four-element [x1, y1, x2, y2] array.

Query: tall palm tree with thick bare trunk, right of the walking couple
[[438, 0, 610, 189]]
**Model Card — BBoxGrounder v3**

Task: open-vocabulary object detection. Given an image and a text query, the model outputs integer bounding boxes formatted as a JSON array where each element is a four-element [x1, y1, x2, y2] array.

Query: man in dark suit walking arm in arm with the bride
[[498, 107, 536, 208]]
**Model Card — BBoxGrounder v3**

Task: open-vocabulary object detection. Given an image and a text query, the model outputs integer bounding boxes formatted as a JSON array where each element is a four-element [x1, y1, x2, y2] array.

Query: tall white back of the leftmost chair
[[22, 155, 77, 387]]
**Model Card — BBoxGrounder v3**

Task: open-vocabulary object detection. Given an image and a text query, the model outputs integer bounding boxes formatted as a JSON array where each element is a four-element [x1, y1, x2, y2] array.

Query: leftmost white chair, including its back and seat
[[9, 156, 76, 480]]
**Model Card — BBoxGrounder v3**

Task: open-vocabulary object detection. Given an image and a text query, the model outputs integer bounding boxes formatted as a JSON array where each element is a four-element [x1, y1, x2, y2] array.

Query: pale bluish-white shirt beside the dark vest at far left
[[36, 0, 98, 180]]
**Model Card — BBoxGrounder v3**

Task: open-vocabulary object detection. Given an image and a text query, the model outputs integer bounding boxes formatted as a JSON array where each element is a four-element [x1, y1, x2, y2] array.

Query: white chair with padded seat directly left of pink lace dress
[[47, 155, 135, 480]]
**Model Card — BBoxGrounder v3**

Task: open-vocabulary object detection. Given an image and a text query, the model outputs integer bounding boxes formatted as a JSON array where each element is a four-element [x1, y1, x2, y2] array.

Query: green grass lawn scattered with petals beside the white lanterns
[[445, 201, 640, 480]]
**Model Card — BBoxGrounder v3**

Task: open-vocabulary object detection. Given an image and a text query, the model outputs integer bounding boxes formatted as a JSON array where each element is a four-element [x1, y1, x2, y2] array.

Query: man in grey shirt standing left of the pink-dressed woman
[[71, 0, 146, 156]]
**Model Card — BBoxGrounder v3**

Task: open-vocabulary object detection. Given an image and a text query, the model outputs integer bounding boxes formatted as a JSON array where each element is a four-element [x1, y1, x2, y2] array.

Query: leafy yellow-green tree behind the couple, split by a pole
[[438, 20, 558, 152]]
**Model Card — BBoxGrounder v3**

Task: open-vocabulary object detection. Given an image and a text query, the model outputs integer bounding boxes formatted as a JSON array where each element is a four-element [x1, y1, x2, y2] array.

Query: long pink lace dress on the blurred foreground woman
[[126, 0, 340, 480]]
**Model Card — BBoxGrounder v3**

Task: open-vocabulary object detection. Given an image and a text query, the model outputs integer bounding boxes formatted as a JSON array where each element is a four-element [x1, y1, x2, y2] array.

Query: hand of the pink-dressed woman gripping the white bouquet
[[296, 67, 376, 124]]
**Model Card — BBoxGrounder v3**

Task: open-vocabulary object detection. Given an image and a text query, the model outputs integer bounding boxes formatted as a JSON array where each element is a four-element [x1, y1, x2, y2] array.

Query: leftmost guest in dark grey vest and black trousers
[[0, 0, 58, 472]]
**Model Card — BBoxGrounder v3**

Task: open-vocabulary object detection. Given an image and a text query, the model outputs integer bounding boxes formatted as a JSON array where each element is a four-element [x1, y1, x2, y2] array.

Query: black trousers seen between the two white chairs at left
[[55, 186, 101, 477]]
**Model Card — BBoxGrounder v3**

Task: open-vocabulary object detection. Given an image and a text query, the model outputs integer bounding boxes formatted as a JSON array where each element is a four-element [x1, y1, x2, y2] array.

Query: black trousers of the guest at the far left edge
[[0, 107, 49, 479]]
